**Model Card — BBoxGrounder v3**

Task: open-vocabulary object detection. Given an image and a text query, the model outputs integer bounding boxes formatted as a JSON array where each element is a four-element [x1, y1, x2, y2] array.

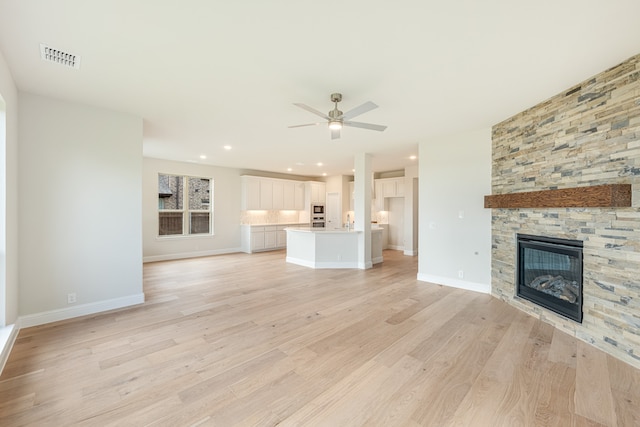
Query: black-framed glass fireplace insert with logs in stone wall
[[516, 234, 583, 323]]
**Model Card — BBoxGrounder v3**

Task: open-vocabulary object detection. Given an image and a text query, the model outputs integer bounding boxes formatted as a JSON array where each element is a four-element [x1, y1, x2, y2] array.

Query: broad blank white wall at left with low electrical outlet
[[18, 93, 144, 326]]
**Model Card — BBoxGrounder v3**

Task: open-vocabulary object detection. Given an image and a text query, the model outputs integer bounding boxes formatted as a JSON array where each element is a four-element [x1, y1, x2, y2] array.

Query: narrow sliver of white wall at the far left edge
[[0, 48, 18, 328]]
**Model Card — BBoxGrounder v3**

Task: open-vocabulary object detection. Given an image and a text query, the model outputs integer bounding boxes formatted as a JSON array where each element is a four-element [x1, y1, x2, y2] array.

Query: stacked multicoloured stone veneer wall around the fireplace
[[491, 55, 640, 368]]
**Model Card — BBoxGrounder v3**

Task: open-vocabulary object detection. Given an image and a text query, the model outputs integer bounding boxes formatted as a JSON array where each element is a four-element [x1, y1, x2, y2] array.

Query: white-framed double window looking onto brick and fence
[[158, 174, 213, 236]]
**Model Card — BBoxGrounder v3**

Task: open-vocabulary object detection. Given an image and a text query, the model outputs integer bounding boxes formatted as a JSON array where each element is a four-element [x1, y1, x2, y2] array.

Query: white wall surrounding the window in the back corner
[[142, 158, 242, 262]]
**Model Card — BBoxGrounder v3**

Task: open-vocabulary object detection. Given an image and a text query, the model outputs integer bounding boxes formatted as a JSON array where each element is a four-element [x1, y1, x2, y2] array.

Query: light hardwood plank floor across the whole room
[[0, 251, 640, 427]]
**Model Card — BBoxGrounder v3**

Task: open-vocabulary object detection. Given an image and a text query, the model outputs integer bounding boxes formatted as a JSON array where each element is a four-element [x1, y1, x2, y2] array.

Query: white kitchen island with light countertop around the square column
[[285, 227, 382, 268]]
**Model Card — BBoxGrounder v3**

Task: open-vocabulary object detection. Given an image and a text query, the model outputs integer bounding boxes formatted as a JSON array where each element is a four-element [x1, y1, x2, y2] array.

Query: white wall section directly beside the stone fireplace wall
[[418, 129, 491, 293]]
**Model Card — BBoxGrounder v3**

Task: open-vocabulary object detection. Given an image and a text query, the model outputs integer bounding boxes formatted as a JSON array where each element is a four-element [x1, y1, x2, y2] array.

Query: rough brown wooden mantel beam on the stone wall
[[484, 184, 631, 209]]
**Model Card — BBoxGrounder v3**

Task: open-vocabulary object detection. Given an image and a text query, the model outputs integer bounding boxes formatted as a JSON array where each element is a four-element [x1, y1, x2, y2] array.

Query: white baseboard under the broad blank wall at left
[[19, 293, 144, 328]]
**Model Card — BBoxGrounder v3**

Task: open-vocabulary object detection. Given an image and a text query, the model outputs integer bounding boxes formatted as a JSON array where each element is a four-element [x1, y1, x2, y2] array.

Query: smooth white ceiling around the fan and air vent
[[0, 0, 640, 176]]
